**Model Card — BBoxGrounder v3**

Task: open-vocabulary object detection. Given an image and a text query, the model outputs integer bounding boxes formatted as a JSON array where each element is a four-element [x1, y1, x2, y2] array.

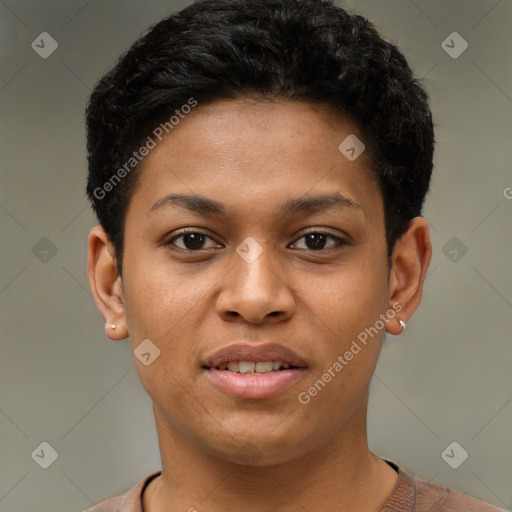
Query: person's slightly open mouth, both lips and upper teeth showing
[[203, 344, 307, 400]]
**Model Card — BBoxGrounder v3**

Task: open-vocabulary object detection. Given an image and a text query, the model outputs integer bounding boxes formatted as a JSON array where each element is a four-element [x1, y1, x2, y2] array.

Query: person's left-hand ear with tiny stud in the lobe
[[87, 226, 128, 340]]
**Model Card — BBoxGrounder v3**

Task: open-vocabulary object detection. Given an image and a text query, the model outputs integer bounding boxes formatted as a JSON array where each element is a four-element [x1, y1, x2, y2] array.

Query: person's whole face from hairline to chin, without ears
[[95, 99, 408, 464]]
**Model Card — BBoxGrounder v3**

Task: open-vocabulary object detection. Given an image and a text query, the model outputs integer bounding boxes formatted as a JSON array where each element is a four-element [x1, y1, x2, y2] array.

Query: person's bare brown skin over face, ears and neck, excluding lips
[[88, 98, 431, 512]]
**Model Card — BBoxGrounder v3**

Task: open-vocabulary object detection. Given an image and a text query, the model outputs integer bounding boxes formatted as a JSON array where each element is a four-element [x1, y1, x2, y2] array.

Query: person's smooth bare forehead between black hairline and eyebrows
[[126, 98, 380, 222]]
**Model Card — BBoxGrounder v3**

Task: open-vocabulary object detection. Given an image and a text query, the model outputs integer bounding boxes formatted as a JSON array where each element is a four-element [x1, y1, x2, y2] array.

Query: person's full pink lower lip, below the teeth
[[206, 368, 304, 400]]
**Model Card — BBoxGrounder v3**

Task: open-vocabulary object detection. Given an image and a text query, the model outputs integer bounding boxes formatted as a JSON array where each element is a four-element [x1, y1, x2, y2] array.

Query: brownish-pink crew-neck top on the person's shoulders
[[84, 461, 503, 512]]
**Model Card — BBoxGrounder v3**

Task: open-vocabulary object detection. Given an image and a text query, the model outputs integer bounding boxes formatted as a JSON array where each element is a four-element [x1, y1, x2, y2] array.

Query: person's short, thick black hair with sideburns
[[86, 0, 435, 275]]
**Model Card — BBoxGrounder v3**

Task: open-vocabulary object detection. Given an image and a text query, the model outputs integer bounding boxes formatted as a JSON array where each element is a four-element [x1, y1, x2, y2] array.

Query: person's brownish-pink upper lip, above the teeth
[[205, 343, 306, 368]]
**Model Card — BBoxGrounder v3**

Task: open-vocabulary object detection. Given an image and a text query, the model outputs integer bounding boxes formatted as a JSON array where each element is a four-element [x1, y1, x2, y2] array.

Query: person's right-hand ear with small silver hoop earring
[[386, 217, 432, 336]]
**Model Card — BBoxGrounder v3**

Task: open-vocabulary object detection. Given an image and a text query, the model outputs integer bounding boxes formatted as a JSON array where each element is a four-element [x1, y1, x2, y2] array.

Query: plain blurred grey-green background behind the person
[[0, 0, 512, 512]]
